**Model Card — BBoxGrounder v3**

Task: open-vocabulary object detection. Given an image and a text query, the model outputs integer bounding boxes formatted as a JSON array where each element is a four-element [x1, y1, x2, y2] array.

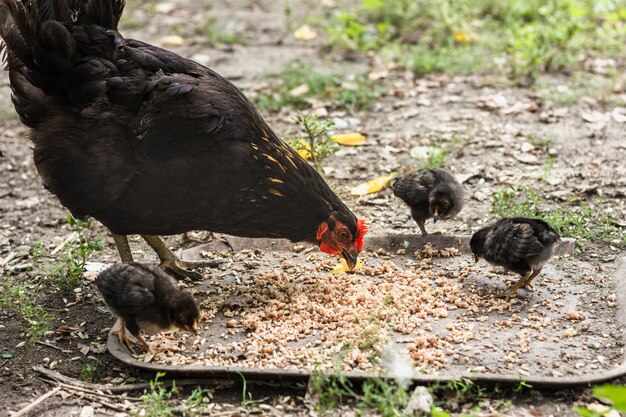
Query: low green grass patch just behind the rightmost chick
[[491, 187, 626, 247]]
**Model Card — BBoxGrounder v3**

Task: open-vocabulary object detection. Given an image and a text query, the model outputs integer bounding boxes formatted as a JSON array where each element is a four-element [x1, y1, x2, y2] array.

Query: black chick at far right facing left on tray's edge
[[470, 217, 561, 298]]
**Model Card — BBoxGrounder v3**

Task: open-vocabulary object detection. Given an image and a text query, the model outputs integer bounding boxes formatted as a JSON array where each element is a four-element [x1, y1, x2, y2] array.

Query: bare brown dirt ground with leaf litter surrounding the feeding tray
[[0, 0, 626, 416]]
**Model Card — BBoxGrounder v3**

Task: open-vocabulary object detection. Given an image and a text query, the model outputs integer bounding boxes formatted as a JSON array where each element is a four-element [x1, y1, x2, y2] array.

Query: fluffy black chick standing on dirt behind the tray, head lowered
[[393, 169, 464, 235]]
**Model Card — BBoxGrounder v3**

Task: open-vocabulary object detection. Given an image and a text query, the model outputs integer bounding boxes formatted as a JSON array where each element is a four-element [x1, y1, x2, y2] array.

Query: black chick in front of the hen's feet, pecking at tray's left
[[96, 263, 200, 353]]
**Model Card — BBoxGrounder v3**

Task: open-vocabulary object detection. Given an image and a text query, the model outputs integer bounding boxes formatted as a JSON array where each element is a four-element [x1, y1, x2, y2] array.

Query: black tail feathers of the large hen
[[0, 0, 124, 127]]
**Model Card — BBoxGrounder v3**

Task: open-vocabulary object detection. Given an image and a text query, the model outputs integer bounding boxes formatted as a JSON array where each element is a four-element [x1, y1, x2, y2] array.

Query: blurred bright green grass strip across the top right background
[[311, 0, 626, 80]]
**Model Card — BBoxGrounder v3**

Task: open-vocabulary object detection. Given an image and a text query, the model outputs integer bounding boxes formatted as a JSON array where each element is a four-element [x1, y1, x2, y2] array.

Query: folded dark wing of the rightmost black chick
[[486, 221, 543, 262]]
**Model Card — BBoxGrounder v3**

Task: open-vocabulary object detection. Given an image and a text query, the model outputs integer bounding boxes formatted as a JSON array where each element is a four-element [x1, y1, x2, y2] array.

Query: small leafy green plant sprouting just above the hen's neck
[[285, 113, 340, 173]]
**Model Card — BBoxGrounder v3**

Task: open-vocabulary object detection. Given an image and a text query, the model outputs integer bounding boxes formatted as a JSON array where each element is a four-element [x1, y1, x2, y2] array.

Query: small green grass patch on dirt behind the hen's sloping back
[[254, 63, 380, 111]]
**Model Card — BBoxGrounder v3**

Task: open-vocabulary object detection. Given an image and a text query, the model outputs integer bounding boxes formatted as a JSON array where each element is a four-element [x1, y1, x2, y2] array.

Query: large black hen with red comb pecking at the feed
[[0, 0, 366, 274]]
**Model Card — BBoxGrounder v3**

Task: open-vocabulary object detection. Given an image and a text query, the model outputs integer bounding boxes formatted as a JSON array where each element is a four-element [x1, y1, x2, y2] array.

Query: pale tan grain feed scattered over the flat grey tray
[[124, 240, 623, 377]]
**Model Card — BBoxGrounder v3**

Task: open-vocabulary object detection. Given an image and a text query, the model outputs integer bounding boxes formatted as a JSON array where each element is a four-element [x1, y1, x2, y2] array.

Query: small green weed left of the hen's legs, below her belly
[[43, 216, 104, 293]]
